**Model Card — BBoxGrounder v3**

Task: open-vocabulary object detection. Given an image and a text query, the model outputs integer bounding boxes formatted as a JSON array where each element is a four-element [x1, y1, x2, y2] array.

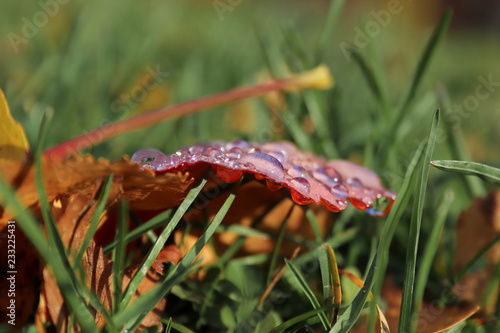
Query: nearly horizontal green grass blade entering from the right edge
[[431, 160, 500, 185]]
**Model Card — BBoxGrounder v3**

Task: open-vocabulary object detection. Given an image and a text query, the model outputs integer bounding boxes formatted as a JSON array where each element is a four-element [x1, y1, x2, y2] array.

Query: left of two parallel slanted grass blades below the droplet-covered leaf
[[120, 177, 207, 308]]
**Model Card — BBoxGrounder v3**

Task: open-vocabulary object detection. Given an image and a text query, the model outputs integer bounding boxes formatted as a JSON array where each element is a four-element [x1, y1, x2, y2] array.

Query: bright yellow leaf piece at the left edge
[[0, 89, 29, 161]]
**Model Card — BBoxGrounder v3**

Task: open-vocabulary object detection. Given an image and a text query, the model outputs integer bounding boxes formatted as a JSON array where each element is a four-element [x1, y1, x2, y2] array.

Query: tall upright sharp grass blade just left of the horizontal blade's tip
[[399, 108, 439, 332]]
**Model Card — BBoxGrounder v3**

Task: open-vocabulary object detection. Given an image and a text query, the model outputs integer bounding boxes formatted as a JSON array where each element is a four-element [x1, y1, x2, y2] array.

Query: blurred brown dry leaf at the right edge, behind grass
[[454, 191, 500, 313]]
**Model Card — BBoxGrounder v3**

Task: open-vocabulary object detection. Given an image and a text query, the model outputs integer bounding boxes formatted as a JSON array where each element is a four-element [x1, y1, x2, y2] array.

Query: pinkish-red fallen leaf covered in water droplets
[[132, 140, 396, 216]]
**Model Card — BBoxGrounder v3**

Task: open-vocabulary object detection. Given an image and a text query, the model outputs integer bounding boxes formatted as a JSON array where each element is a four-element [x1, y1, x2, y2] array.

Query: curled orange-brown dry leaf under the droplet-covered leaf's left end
[[0, 155, 194, 228]]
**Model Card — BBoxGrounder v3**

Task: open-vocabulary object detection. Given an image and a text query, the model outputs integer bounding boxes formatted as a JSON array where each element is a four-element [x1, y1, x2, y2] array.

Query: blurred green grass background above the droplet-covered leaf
[[0, 0, 500, 164]]
